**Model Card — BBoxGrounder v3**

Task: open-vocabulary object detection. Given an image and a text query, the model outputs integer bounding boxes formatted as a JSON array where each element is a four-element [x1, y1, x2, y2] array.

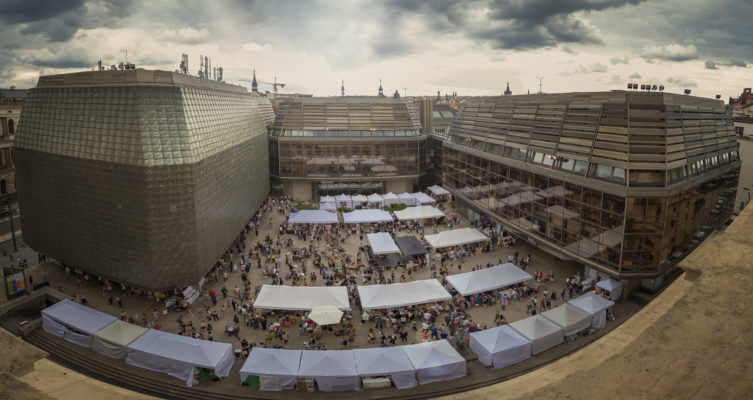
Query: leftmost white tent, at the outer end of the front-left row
[[42, 299, 118, 348]]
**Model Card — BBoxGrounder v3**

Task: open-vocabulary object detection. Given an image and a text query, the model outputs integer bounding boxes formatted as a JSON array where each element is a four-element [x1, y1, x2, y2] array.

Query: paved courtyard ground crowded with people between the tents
[[26, 200, 604, 383]]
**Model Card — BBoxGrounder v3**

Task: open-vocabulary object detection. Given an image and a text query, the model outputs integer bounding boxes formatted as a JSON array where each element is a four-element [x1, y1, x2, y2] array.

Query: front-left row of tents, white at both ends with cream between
[[42, 299, 234, 386]]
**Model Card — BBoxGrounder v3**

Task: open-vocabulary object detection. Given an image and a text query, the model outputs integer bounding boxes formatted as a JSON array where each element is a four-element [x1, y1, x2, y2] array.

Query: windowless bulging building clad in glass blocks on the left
[[15, 70, 269, 288]]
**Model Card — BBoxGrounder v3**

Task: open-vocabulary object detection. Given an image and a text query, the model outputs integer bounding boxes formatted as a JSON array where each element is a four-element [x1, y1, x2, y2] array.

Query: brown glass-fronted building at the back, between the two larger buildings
[[269, 97, 427, 201]]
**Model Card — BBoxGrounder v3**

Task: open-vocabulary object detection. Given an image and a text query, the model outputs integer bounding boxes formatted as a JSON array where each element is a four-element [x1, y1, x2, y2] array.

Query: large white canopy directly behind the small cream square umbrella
[[254, 285, 350, 311]]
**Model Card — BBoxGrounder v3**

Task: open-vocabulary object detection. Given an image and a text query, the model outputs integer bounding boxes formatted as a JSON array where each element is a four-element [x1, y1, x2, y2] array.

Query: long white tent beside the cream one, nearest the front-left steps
[[126, 329, 235, 386]]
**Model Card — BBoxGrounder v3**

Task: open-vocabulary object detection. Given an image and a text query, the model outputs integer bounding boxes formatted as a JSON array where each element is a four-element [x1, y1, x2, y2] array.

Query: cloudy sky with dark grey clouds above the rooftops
[[0, 0, 753, 99]]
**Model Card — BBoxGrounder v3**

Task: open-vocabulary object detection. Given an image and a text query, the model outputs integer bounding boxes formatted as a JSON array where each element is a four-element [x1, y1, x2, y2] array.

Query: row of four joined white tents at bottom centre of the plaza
[[240, 340, 466, 392]]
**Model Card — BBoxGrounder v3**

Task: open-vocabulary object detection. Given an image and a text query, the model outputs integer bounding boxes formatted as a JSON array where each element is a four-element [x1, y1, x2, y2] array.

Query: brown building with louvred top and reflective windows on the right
[[442, 91, 740, 288]]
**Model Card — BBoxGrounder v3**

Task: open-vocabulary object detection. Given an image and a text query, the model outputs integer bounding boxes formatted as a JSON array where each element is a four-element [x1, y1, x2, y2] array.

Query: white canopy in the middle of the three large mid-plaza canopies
[[358, 279, 452, 310]]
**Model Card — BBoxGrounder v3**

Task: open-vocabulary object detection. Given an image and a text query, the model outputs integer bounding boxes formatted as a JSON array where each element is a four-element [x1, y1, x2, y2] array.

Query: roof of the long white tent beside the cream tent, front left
[[128, 329, 232, 369]]
